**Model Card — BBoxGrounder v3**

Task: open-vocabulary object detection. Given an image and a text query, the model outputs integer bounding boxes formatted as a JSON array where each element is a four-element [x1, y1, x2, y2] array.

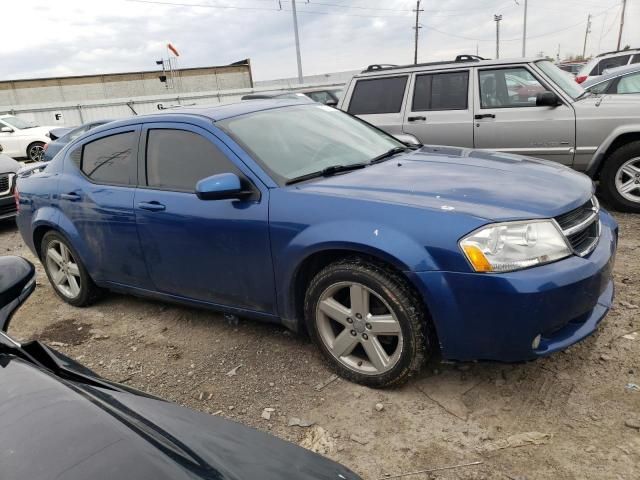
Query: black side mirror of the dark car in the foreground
[[0, 257, 36, 332]]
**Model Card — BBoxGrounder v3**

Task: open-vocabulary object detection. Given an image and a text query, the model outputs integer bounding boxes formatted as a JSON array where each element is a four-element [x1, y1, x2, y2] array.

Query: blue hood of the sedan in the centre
[[296, 146, 593, 221]]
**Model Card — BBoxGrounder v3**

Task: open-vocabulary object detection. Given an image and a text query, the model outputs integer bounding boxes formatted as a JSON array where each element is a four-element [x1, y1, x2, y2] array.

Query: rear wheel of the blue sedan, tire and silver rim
[[40, 231, 102, 307]]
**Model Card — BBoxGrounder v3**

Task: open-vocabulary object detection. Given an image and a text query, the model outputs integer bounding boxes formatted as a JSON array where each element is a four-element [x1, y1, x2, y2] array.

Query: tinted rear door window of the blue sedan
[[80, 132, 138, 185]]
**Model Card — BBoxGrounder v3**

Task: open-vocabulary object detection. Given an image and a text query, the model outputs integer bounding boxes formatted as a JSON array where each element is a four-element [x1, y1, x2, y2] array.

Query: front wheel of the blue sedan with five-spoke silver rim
[[304, 257, 431, 388]]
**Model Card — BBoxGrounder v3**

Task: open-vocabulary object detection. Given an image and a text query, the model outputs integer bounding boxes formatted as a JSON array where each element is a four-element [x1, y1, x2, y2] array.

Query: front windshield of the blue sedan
[[216, 105, 405, 184]]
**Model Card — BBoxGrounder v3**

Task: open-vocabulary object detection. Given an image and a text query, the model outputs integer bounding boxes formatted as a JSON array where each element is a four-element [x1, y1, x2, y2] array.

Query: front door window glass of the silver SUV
[[479, 67, 545, 108]]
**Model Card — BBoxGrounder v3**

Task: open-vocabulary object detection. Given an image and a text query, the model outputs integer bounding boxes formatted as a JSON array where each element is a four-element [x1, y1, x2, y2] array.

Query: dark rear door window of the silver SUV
[[412, 71, 469, 112]]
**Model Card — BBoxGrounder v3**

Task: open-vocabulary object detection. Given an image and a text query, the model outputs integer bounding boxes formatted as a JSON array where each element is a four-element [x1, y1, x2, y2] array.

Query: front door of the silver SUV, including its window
[[474, 66, 575, 165]]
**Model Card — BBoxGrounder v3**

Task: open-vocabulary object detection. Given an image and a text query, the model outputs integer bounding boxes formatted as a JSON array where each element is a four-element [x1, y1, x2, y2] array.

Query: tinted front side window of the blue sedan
[[147, 129, 240, 192]]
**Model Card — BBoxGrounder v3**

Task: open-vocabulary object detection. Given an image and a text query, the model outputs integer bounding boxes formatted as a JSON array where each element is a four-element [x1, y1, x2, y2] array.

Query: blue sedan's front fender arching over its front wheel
[[273, 220, 437, 324]]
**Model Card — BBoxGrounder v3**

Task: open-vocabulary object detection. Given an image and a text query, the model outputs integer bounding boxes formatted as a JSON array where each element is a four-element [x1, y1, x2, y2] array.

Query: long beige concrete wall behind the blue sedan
[[0, 64, 252, 107]]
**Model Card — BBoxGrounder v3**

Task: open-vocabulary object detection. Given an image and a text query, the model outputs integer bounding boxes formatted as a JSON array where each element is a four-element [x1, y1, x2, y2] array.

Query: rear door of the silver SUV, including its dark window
[[403, 69, 473, 147]]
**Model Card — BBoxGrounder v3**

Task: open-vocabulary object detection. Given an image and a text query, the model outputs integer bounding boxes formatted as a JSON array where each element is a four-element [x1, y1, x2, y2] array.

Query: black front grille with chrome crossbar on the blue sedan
[[555, 196, 600, 257]]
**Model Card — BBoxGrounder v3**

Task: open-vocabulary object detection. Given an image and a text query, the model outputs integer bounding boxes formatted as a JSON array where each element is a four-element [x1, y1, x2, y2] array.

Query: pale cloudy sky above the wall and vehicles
[[0, 0, 640, 80]]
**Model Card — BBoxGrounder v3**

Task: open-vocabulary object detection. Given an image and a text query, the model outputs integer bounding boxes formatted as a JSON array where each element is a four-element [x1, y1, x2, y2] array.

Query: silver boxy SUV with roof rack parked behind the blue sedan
[[338, 55, 640, 212]]
